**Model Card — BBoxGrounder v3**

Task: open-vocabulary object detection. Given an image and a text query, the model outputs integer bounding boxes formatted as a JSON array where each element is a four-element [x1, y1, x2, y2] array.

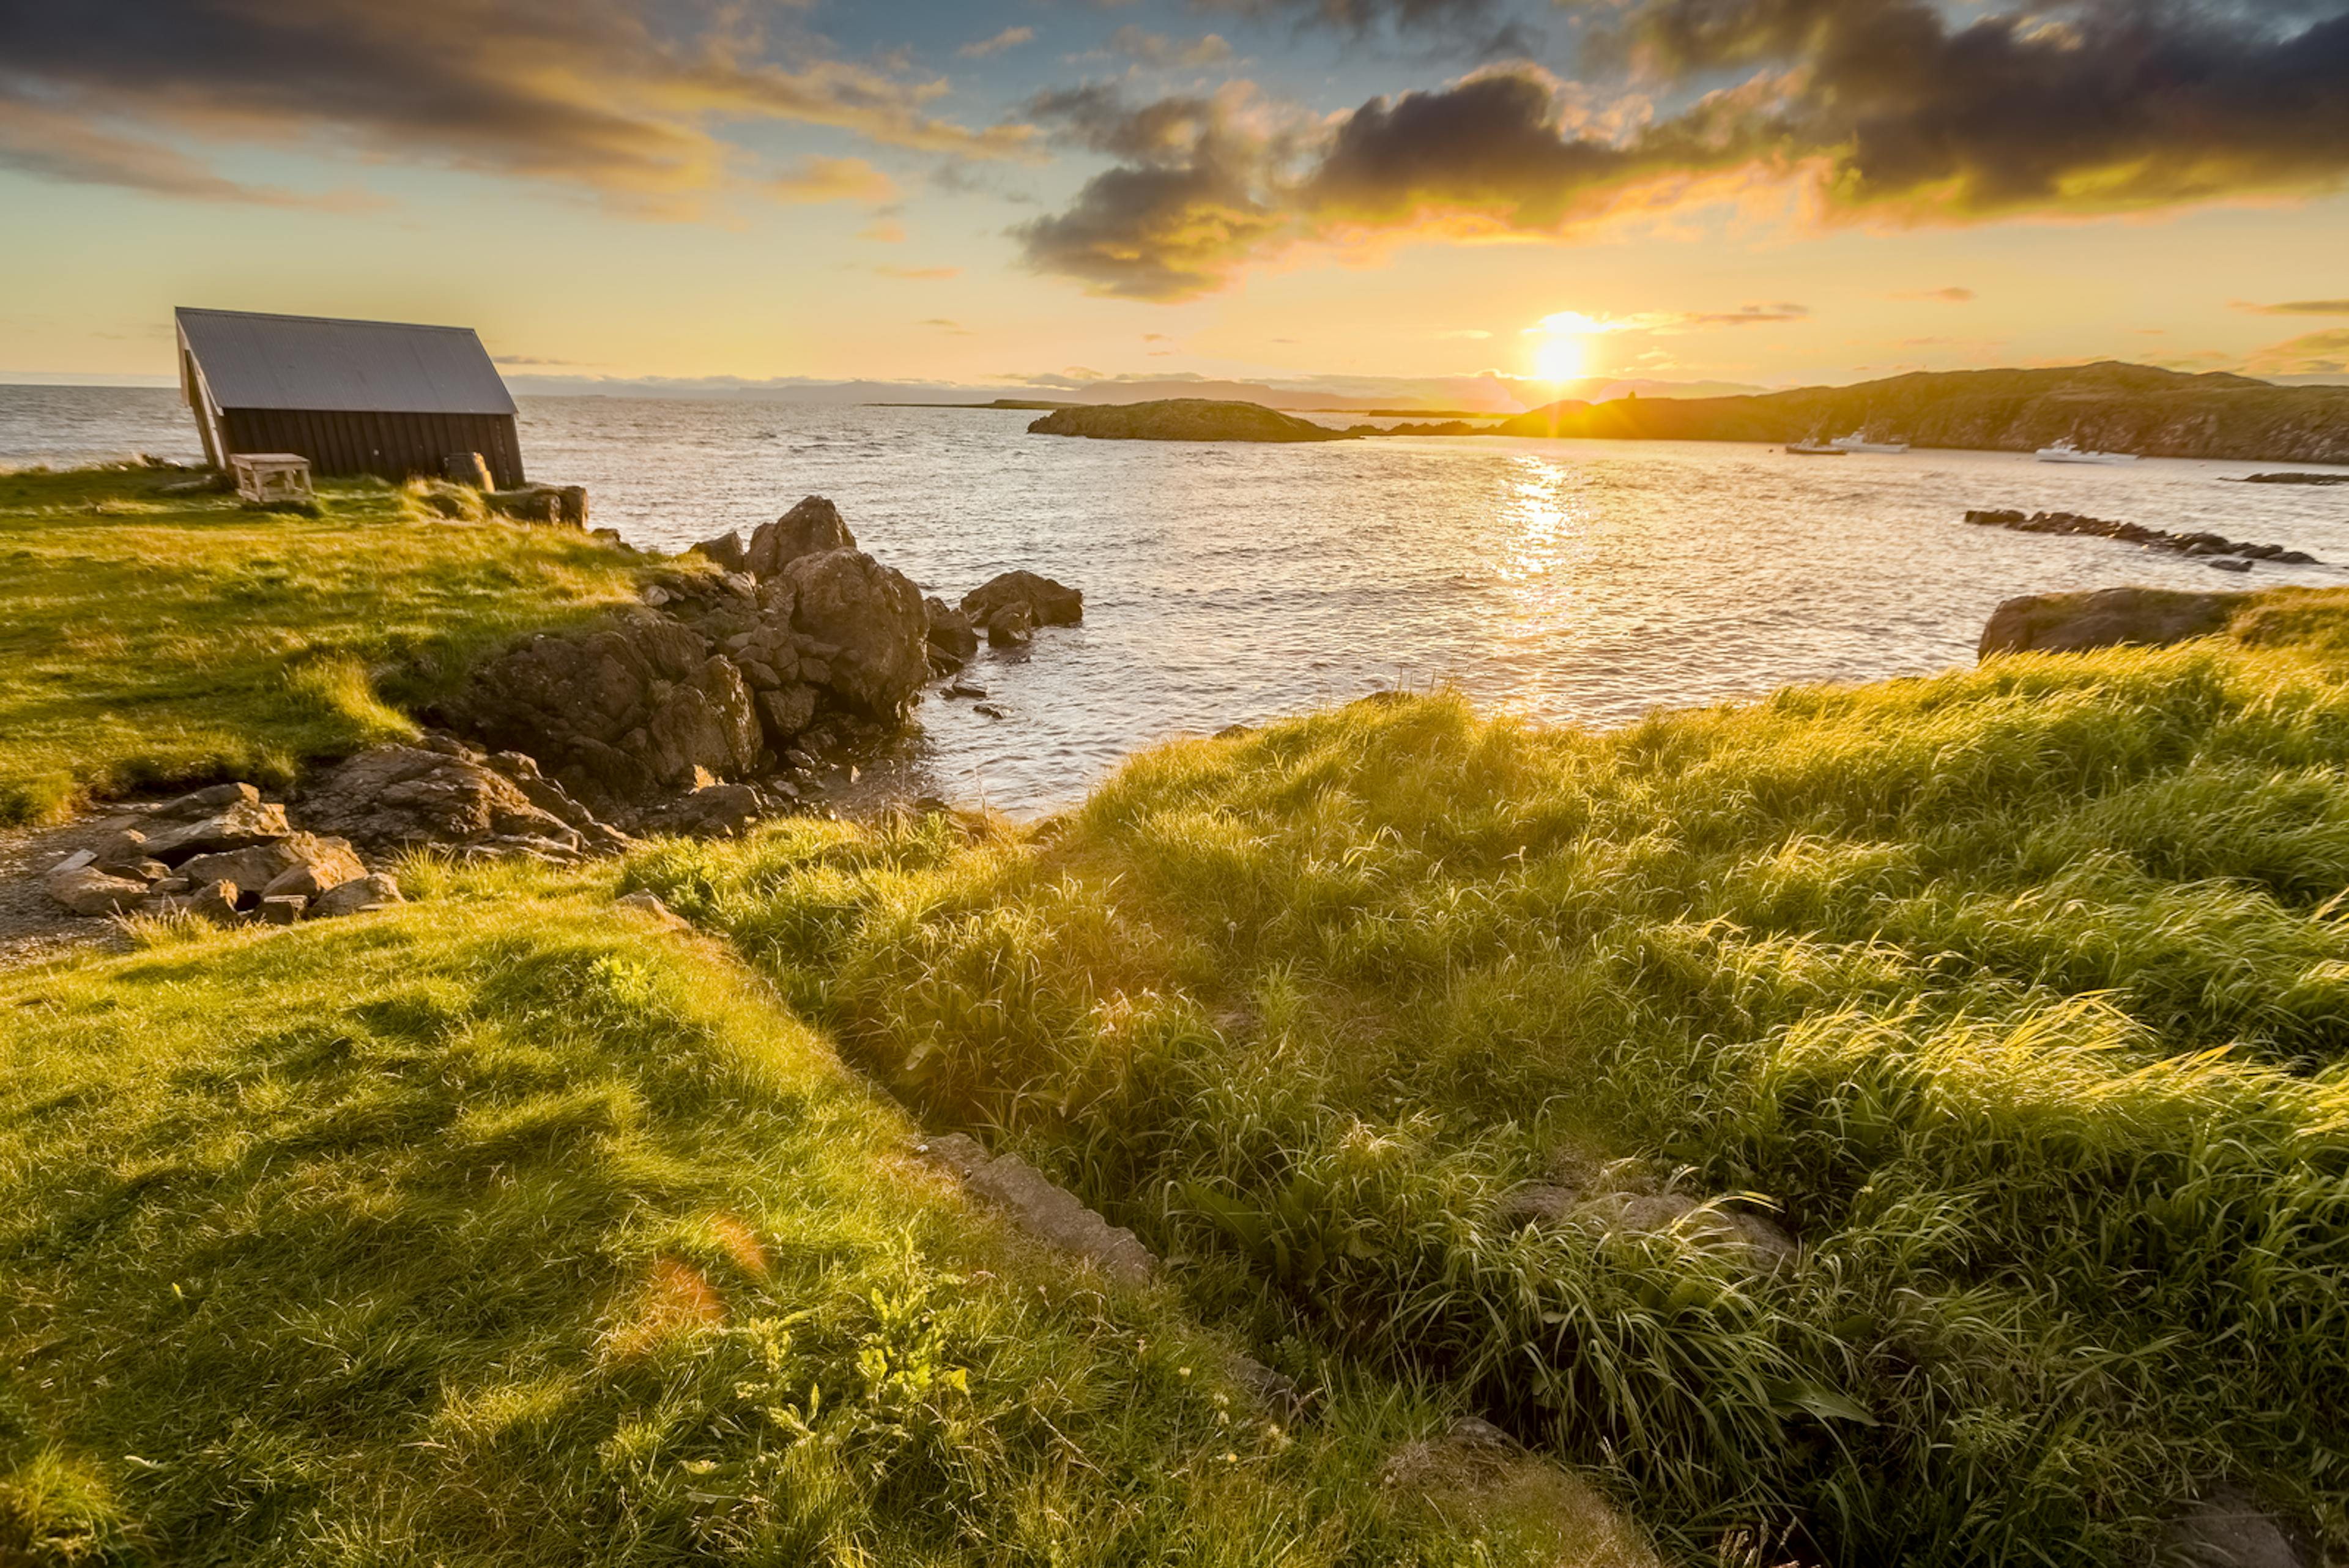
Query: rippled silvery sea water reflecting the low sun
[[18, 388, 2349, 811]]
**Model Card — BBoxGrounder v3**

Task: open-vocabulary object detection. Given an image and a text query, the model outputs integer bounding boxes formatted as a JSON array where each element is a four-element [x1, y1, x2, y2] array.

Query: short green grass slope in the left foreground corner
[[0, 865, 1642, 1568]]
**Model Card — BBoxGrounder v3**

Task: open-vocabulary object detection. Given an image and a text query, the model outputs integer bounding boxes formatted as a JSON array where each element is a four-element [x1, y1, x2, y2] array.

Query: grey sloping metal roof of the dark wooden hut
[[176, 306, 514, 414]]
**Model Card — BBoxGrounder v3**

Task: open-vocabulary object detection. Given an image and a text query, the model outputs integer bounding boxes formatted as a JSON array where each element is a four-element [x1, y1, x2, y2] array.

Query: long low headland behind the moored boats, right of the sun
[[1494, 360, 2349, 463]]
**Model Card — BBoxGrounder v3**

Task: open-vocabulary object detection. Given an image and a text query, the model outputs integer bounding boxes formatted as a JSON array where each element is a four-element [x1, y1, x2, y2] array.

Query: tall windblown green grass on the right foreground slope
[[634, 611, 2349, 1563]]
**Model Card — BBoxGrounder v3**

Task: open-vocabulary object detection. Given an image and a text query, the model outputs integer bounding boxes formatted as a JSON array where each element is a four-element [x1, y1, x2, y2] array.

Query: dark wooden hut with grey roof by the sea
[[176, 308, 524, 489]]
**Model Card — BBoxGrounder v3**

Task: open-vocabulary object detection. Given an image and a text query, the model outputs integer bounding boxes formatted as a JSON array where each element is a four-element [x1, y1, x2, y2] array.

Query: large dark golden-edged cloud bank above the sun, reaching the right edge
[[1017, 0, 2349, 303]]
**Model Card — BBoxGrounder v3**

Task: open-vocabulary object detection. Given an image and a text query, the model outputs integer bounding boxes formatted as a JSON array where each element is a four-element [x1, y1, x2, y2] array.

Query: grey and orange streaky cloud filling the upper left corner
[[0, 0, 1031, 214]]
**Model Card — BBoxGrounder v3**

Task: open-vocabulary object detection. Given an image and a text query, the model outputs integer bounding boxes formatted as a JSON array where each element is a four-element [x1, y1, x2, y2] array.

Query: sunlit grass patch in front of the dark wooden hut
[[0, 468, 641, 825]]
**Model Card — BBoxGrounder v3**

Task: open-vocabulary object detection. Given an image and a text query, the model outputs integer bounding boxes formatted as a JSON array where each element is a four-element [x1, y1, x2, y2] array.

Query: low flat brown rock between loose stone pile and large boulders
[[301, 745, 580, 853]]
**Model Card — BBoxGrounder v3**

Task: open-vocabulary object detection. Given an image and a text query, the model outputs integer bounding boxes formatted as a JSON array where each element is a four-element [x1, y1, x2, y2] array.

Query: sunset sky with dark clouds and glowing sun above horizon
[[0, 0, 2349, 402]]
